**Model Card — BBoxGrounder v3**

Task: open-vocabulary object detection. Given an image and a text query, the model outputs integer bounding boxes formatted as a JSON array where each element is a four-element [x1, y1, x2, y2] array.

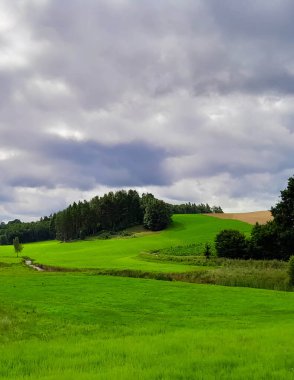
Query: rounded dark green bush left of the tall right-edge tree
[[215, 230, 248, 259]]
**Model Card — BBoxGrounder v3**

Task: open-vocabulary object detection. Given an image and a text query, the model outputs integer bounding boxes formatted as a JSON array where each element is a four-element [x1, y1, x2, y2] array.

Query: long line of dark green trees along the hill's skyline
[[0, 190, 222, 245]]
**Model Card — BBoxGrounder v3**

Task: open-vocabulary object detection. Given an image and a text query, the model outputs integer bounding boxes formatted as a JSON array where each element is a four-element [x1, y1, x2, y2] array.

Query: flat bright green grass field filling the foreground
[[0, 264, 294, 380]]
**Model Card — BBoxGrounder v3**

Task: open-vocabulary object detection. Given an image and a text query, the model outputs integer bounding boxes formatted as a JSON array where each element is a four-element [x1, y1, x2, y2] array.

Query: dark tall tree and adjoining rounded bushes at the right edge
[[215, 177, 294, 260]]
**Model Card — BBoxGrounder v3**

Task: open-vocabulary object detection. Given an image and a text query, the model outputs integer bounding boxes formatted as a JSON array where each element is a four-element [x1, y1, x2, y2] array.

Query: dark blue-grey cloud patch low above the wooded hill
[[38, 140, 169, 189]]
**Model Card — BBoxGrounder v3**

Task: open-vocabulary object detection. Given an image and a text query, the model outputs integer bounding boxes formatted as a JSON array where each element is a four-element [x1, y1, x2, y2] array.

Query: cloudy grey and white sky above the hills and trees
[[0, 0, 294, 221]]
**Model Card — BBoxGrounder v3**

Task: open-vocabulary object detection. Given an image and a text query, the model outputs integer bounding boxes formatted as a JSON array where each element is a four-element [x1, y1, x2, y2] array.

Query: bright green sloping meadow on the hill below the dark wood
[[0, 215, 252, 272]]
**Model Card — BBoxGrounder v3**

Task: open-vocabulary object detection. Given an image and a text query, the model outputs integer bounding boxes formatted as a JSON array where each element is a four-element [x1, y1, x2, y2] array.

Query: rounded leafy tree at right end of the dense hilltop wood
[[143, 199, 171, 231]]
